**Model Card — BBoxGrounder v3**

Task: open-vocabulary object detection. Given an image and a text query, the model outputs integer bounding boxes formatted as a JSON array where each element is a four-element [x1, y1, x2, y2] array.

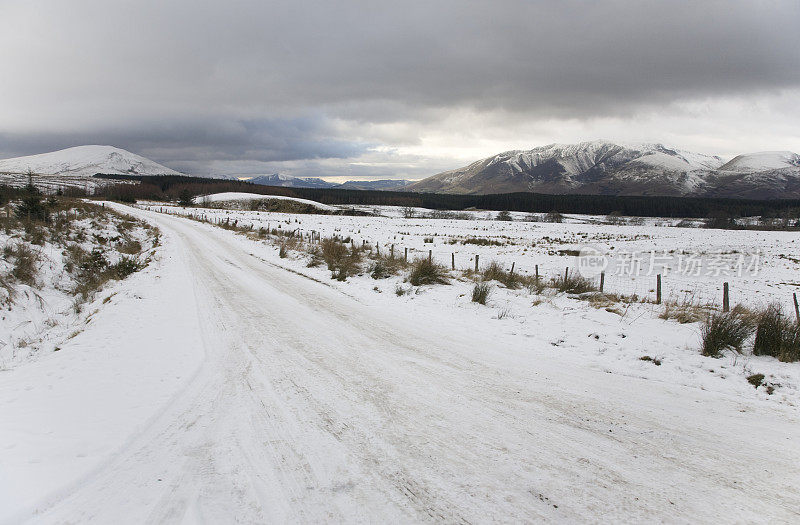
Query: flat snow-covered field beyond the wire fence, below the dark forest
[[159, 199, 800, 308]]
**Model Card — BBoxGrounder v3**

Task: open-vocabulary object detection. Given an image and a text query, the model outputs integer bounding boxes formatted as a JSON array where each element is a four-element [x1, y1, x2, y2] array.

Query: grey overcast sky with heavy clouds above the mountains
[[0, 0, 800, 179]]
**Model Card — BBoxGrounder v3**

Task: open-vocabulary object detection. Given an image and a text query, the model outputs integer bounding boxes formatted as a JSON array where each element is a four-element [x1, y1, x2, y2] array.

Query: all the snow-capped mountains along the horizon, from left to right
[[0, 140, 800, 199]]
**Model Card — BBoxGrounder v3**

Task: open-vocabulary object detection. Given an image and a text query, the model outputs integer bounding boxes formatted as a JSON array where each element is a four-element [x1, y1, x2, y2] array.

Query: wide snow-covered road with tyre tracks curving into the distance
[[10, 208, 800, 523]]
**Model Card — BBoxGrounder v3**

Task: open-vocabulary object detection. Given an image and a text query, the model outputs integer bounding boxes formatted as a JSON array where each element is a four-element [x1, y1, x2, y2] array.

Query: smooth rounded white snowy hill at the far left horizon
[[0, 146, 183, 177]]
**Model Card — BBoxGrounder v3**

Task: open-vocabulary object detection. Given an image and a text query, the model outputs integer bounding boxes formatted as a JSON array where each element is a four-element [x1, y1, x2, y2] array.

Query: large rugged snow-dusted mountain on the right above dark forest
[[408, 140, 800, 198]]
